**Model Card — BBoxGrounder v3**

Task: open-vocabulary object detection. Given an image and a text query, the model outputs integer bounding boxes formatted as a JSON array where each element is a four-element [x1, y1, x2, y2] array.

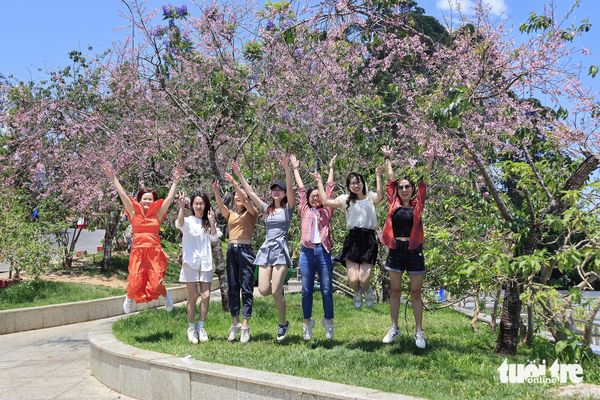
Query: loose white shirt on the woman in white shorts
[[175, 215, 223, 272]]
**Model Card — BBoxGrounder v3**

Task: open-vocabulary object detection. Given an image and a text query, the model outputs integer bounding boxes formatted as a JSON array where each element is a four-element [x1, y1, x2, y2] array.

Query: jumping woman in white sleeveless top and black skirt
[[313, 167, 384, 308]]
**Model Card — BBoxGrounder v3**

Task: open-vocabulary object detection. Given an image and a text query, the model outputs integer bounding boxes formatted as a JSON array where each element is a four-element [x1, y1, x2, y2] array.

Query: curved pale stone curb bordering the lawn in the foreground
[[89, 329, 417, 400]]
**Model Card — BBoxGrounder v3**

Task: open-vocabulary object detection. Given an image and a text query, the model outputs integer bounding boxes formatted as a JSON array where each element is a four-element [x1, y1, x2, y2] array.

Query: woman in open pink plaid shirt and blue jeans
[[290, 155, 336, 340]]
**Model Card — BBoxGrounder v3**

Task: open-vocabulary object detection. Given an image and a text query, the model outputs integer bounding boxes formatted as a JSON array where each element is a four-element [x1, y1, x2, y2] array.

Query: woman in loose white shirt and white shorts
[[175, 193, 223, 344]]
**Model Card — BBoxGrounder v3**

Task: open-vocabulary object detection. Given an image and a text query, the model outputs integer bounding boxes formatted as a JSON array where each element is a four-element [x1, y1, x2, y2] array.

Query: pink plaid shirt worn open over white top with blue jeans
[[298, 182, 334, 252]]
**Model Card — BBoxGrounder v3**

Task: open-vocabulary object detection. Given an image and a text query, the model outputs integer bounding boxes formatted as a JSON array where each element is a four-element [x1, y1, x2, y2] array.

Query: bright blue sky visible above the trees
[[0, 0, 600, 88]]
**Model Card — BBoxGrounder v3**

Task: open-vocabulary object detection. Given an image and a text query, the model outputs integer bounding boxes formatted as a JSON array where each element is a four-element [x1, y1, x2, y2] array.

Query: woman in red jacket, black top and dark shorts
[[381, 146, 427, 349]]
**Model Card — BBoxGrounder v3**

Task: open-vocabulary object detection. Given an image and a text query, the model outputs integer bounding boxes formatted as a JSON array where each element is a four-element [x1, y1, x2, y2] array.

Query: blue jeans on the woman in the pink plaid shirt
[[300, 245, 333, 319]]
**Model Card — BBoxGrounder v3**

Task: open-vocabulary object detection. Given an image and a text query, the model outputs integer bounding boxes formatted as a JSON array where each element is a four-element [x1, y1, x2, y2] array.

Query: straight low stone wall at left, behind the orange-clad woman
[[0, 286, 187, 335]]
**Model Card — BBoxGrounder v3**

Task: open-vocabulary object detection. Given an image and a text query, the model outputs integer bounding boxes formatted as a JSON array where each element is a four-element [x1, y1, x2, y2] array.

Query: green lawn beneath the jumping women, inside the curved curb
[[113, 294, 599, 399]]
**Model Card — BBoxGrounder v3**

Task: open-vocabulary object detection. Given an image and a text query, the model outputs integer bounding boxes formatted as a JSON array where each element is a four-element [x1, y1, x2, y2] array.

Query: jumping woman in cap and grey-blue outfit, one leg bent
[[232, 156, 295, 342]]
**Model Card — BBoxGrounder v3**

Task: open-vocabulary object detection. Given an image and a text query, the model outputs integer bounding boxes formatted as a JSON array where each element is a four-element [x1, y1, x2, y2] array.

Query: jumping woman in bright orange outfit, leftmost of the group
[[102, 164, 182, 314]]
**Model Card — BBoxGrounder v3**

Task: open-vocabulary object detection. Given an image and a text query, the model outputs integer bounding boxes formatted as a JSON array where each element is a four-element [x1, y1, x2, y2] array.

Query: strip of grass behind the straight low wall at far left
[[0, 280, 125, 310]]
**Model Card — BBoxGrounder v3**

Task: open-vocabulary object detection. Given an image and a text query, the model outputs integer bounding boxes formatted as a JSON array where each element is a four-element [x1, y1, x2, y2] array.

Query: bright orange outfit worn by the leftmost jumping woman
[[125, 197, 167, 303]]
